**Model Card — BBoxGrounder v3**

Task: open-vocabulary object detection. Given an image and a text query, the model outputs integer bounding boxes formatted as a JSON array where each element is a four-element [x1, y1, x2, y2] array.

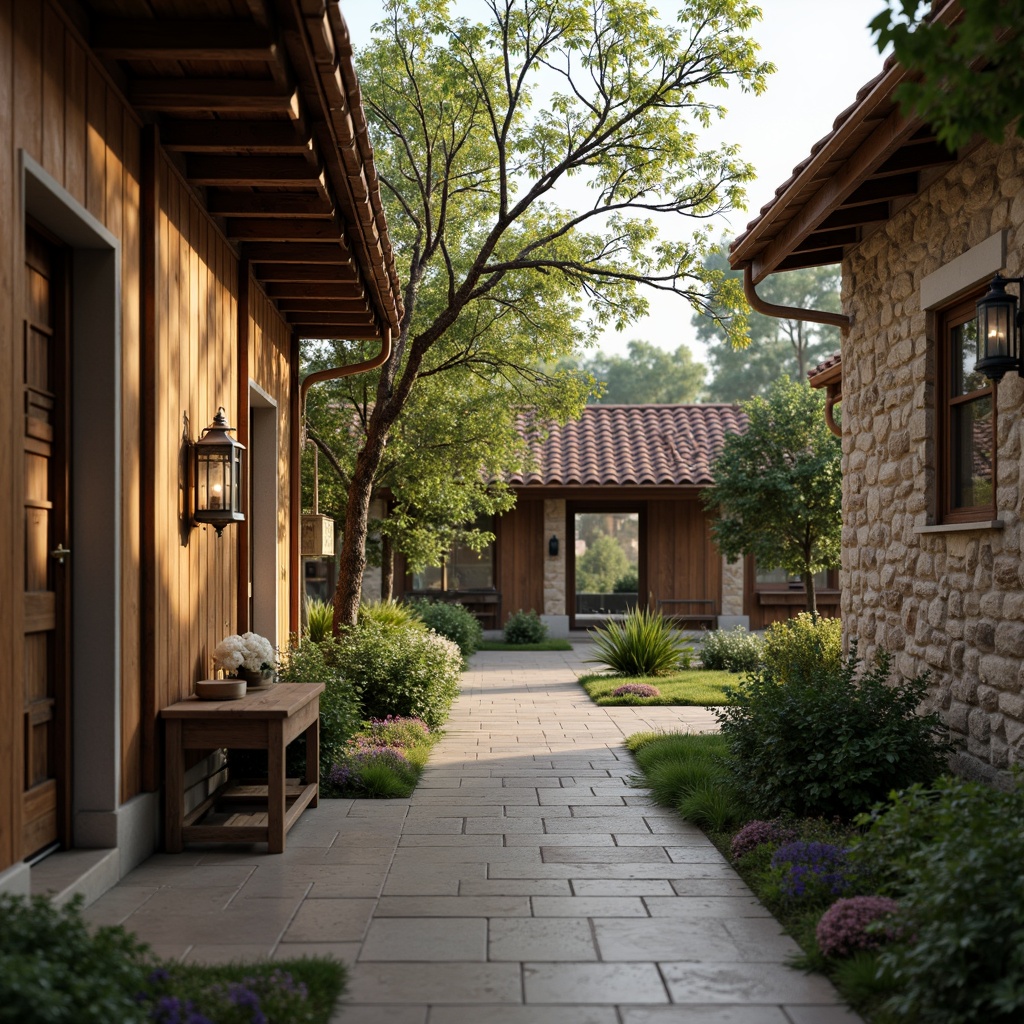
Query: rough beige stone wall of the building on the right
[[841, 139, 1024, 775]]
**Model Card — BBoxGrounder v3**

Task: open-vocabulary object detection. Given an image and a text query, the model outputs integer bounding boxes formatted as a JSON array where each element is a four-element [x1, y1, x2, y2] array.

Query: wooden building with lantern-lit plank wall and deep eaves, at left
[[0, 0, 400, 891]]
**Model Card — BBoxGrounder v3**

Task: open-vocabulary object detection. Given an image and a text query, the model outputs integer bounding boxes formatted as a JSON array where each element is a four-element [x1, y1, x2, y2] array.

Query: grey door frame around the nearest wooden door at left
[[18, 150, 126, 856]]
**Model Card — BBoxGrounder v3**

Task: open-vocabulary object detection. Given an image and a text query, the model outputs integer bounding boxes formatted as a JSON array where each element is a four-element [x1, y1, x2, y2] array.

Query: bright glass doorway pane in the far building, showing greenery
[[574, 512, 640, 625]]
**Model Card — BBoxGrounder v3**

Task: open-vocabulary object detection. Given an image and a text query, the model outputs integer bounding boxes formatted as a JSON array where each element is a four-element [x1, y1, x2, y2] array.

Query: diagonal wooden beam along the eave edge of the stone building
[[751, 108, 920, 284]]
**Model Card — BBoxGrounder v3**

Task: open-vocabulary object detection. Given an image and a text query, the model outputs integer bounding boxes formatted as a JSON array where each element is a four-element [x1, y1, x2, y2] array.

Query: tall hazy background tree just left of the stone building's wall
[[692, 243, 840, 401]]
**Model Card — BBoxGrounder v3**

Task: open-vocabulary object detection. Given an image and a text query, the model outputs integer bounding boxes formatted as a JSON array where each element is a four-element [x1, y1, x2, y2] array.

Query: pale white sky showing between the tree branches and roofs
[[341, 0, 885, 361]]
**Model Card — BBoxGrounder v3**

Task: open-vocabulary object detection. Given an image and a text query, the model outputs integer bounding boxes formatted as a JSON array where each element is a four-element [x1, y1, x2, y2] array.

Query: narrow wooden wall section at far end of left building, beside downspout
[[247, 278, 292, 640]]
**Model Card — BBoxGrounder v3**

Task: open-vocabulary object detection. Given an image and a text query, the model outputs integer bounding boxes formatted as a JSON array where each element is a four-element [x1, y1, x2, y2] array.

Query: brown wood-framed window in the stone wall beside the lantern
[[938, 298, 996, 522]]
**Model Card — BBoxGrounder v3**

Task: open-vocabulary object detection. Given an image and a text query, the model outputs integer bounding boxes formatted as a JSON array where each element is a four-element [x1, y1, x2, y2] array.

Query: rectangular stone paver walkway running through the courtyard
[[86, 645, 859, 1024]]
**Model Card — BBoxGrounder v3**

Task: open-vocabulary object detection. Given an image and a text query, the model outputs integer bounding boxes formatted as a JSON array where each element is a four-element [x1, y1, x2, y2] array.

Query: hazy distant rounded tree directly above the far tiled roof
[[581, 340, 705, 406]]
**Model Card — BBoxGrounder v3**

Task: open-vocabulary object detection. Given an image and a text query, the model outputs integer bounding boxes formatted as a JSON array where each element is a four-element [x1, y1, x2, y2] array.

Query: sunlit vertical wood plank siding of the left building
[[0, 0, 291, 870]]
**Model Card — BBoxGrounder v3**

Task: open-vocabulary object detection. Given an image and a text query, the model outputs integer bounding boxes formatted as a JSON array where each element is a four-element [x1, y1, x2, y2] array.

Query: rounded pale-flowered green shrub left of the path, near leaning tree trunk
[[338, 621, 462, 729]]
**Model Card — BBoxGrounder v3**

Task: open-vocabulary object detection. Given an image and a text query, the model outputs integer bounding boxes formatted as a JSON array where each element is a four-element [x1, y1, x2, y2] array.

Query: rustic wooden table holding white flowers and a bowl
[[160, 683, 324, 853]]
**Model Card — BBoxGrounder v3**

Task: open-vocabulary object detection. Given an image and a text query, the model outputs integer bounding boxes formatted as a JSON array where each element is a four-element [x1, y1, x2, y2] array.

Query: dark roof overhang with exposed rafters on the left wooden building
[[79, 0, 402, 339]]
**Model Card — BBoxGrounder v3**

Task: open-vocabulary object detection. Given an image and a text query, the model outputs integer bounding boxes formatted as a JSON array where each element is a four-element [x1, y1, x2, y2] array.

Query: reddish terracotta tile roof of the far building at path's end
[[508, 404, 746, 486]]
